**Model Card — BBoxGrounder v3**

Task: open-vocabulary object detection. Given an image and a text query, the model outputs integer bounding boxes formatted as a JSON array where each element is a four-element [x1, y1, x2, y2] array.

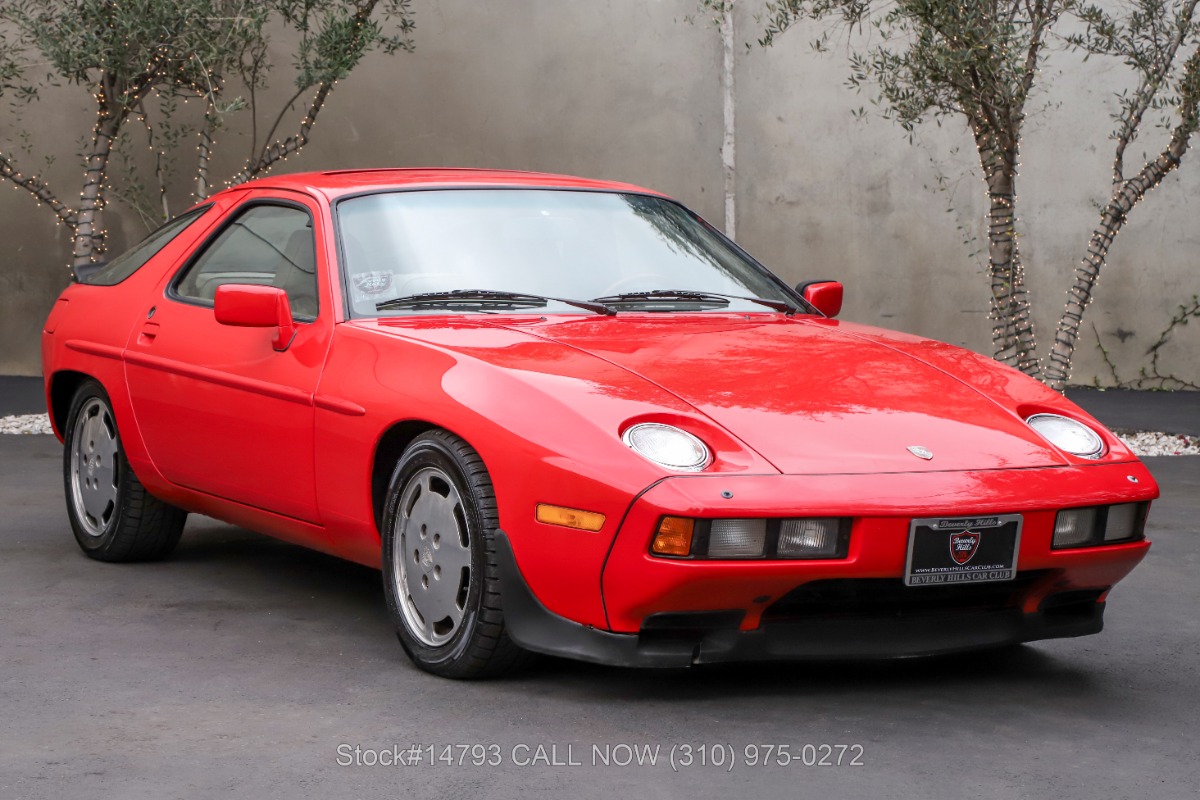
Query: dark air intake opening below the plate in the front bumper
[[763, 570, 1048, 622]]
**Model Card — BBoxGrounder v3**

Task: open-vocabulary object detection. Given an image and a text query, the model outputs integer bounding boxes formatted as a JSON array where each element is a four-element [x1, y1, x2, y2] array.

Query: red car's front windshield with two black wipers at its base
[[337, 188, 799, 317]]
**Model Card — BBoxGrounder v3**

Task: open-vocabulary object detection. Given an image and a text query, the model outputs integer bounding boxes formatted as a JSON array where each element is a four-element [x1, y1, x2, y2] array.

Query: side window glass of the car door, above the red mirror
[[175, 205, 318, 320]]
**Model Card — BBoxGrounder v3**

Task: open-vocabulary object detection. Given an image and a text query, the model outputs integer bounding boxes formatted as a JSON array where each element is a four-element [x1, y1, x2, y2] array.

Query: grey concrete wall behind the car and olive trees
[[0, 0, 1200, 384]]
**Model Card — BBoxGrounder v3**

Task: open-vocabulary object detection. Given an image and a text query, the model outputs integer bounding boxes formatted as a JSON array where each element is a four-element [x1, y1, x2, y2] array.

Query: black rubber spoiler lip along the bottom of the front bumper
[[496, 531, 1104, 667]]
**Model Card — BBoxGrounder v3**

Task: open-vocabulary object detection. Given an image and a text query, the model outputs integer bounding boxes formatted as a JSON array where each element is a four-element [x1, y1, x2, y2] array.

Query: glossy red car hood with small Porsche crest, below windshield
[[360, 313, 1068, 475]]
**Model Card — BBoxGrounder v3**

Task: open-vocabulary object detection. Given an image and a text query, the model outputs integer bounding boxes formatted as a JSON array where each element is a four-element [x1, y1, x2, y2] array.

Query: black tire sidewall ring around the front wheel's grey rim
[[382, 437, 491, 674]]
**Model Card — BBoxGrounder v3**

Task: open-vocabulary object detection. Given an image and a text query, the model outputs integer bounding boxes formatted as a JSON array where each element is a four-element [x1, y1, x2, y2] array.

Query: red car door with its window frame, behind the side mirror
[[126, 190, 332, 523]]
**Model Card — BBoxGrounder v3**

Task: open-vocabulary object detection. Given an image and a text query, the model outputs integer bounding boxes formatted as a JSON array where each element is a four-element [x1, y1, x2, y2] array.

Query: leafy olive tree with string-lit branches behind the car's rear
[[0, 0, 413, 267]]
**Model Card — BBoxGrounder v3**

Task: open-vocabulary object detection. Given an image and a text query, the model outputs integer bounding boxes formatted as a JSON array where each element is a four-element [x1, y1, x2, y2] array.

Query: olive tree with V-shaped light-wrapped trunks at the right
[[701, 0, 1200, 389]]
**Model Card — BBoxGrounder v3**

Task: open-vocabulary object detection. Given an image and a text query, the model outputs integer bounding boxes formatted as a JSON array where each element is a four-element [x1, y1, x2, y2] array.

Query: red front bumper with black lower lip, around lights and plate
[[498, 462, 1158, 667]]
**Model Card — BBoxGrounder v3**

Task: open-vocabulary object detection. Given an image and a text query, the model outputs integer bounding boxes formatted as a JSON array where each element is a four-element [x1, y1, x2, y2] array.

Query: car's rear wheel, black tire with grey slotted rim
[[62, 380, 187, 561]]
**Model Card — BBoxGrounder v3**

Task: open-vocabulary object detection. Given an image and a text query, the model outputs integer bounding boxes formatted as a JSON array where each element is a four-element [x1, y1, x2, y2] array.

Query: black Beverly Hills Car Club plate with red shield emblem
[[904, 513, 1021, 587]]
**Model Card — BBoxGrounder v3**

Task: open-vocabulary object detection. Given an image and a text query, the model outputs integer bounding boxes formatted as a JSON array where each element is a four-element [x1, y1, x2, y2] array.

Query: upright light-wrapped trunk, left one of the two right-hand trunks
[[977, 137, 1038, 378]]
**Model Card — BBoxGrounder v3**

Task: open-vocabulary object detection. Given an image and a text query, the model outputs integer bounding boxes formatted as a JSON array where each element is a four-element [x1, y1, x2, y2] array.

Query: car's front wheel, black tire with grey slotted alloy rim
[[383, 431, 529, 679]]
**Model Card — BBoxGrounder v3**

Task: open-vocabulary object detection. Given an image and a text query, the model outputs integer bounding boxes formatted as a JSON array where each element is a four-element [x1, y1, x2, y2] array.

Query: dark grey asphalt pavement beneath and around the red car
[[0, 384, 1200, 800]]
